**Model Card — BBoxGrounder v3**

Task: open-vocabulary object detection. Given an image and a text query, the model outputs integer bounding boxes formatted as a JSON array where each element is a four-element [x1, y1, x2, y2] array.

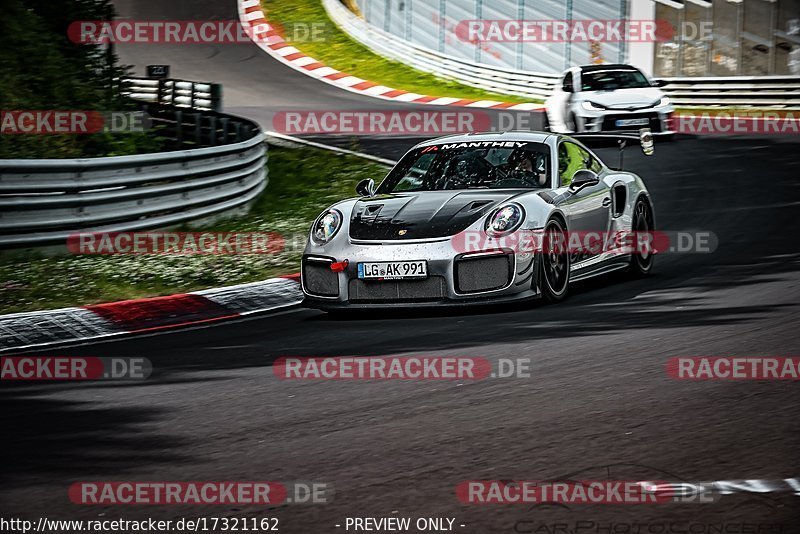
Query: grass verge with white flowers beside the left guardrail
[[0, 146, 386, 313]]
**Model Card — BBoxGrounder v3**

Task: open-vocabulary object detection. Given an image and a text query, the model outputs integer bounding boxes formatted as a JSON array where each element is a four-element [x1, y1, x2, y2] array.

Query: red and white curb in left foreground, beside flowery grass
[[0, 275, 303, 352]]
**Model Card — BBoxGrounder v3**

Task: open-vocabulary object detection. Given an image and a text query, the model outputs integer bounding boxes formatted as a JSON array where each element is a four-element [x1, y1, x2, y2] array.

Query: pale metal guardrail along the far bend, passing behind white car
[[323, 0, 800, 108]]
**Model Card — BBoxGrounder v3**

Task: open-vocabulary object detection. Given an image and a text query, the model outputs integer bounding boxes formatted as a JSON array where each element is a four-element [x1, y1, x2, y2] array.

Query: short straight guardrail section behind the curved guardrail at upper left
[[123, 77, 222, 111]]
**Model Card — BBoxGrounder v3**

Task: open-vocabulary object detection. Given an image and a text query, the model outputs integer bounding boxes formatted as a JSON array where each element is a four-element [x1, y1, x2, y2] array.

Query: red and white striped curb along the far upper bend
[[238, 0, 544, 111]]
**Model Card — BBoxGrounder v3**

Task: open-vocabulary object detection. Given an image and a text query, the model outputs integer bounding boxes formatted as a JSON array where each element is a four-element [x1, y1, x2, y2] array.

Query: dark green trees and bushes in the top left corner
[[0, 0, 163, 158]]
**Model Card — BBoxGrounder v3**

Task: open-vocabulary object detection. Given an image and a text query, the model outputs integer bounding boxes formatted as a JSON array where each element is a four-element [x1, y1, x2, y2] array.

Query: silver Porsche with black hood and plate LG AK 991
[[301, 130, 655, 310]]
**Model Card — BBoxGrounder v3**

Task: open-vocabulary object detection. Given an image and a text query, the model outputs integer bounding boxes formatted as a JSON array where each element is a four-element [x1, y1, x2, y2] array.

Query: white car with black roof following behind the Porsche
[[545, 65, 675, 135]]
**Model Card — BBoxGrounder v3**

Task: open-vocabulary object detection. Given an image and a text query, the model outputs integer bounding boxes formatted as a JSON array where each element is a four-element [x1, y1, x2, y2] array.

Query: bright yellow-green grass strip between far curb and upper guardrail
[[261, 0, 541, 103]]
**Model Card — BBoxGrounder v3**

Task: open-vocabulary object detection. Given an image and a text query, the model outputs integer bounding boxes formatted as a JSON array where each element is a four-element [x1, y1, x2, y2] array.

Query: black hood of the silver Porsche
[[350, 189, 520, 241]]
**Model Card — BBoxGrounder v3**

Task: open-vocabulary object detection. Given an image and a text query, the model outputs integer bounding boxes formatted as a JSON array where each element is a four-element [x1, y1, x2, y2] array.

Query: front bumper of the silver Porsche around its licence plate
[[301, 238, 538, 309]]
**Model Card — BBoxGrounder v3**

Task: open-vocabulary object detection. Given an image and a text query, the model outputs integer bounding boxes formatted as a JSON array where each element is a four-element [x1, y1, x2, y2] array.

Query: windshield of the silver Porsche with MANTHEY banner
[[377, 141, 550, 194]]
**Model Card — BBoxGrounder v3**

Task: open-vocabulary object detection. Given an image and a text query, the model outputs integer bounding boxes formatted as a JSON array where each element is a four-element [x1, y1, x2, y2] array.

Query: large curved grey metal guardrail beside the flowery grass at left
[[0, 80, 267, 248]]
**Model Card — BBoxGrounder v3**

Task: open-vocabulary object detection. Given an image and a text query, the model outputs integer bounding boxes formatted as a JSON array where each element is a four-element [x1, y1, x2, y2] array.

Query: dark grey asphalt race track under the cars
[[0, 0, 800, 533]]
